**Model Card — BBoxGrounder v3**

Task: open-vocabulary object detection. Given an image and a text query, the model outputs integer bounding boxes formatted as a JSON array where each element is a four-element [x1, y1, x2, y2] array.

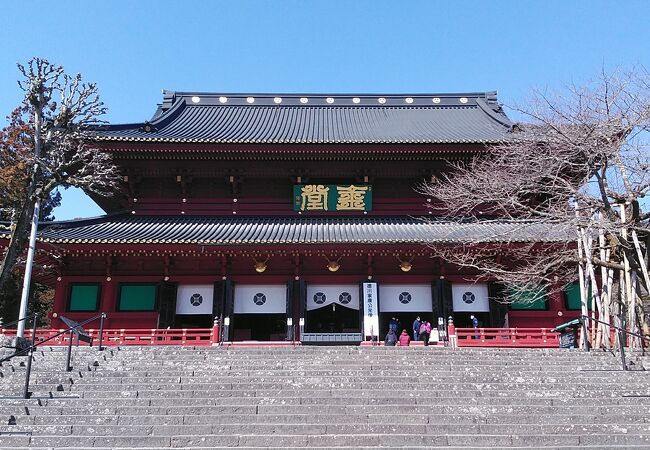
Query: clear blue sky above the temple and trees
[[0, 0, 650, 219]]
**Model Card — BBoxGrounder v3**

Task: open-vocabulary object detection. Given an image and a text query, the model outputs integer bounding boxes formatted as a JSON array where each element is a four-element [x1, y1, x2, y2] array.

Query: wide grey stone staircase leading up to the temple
[[0, 346, 650, 449]]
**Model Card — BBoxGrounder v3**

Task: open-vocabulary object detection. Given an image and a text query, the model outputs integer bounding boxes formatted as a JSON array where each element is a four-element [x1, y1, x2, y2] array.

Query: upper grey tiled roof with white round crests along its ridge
[[97, 91, 512, 144]]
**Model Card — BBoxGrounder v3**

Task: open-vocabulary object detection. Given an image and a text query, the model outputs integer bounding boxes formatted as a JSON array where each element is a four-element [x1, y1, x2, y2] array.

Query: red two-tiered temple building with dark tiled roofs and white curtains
[[0, 91, 579, 343]]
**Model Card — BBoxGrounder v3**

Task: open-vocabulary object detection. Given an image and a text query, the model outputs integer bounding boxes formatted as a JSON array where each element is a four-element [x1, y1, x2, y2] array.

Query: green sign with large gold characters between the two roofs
[[293, 184, 372, 212]]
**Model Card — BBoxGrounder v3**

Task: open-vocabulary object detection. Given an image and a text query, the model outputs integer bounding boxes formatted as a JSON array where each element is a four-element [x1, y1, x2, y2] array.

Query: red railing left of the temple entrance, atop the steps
[[0, 327, 219, 346]]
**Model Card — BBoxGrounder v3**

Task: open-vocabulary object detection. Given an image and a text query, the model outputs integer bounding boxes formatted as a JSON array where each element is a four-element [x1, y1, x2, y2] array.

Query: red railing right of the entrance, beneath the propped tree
[[456, 328, 560, 347]]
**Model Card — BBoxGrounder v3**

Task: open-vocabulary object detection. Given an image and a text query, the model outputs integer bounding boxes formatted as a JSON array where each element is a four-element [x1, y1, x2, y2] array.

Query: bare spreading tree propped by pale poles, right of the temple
[[422, 70, 650, 346]]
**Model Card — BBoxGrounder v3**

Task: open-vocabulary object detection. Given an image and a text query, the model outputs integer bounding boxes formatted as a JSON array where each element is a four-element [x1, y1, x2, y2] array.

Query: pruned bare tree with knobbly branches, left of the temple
[[0, 58, 118, 302]]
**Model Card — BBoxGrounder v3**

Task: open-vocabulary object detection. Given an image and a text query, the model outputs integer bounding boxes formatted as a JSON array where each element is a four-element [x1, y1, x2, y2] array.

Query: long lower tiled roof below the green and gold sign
[[16, 215, 572, 245]]
